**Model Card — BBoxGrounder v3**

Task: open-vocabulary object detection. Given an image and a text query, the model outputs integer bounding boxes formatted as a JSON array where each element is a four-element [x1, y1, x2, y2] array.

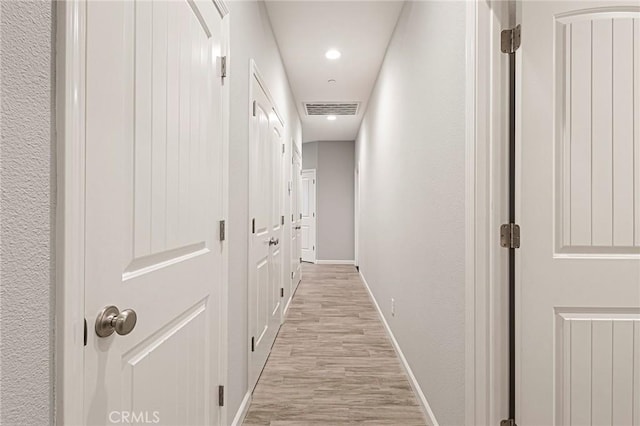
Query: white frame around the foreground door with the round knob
[[54, 0, 229, 425]]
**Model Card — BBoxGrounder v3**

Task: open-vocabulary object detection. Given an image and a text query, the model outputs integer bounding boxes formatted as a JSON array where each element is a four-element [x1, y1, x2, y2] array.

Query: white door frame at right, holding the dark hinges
[[465, 0, 514, 425]]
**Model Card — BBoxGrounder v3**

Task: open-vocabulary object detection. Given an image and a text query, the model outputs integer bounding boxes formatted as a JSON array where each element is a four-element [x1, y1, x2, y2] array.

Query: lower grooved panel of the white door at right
[[556, 308, 640, 425]]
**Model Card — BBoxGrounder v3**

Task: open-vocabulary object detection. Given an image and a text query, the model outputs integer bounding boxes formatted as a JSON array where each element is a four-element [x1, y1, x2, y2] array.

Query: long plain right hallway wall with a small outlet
[[356, 1, 465, 425]]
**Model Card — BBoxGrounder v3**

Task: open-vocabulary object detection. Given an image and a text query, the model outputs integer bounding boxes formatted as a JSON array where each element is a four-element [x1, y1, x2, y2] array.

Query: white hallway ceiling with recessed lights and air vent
[[265, 0, 403, 142]]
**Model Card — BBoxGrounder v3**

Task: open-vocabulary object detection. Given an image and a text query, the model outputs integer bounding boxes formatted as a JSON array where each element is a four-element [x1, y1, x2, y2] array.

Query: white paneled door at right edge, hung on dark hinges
[[516, 1, 640, 426]]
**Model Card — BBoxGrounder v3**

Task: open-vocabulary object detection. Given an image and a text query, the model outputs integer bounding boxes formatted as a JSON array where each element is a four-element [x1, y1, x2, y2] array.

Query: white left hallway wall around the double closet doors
[[226, 1, 302, 421]]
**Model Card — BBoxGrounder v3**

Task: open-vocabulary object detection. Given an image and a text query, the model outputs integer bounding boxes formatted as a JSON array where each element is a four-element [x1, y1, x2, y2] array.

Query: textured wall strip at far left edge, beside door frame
[[0, 1, 55, 425]]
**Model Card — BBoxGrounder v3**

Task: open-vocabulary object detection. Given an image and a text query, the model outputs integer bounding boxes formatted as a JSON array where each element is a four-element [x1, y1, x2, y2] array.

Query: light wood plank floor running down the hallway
[[244, 264, 425, 426]]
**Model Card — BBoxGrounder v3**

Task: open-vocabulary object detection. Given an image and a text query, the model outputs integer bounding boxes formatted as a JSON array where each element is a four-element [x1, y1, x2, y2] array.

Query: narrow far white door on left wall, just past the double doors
[[289, 141, 302, 295]]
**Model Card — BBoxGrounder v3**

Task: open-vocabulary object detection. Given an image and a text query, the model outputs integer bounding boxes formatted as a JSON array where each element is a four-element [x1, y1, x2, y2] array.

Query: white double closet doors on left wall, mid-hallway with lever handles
[[249, 73, 284, 389]]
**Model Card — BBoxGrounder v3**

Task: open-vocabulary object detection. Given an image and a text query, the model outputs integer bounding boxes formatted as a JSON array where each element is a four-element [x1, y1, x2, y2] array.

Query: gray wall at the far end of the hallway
[[302, 141, 355, 260]]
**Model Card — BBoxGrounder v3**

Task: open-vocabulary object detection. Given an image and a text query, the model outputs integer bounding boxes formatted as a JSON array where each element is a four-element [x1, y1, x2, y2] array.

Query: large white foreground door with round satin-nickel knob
[[84, 1, 227, 425]]
